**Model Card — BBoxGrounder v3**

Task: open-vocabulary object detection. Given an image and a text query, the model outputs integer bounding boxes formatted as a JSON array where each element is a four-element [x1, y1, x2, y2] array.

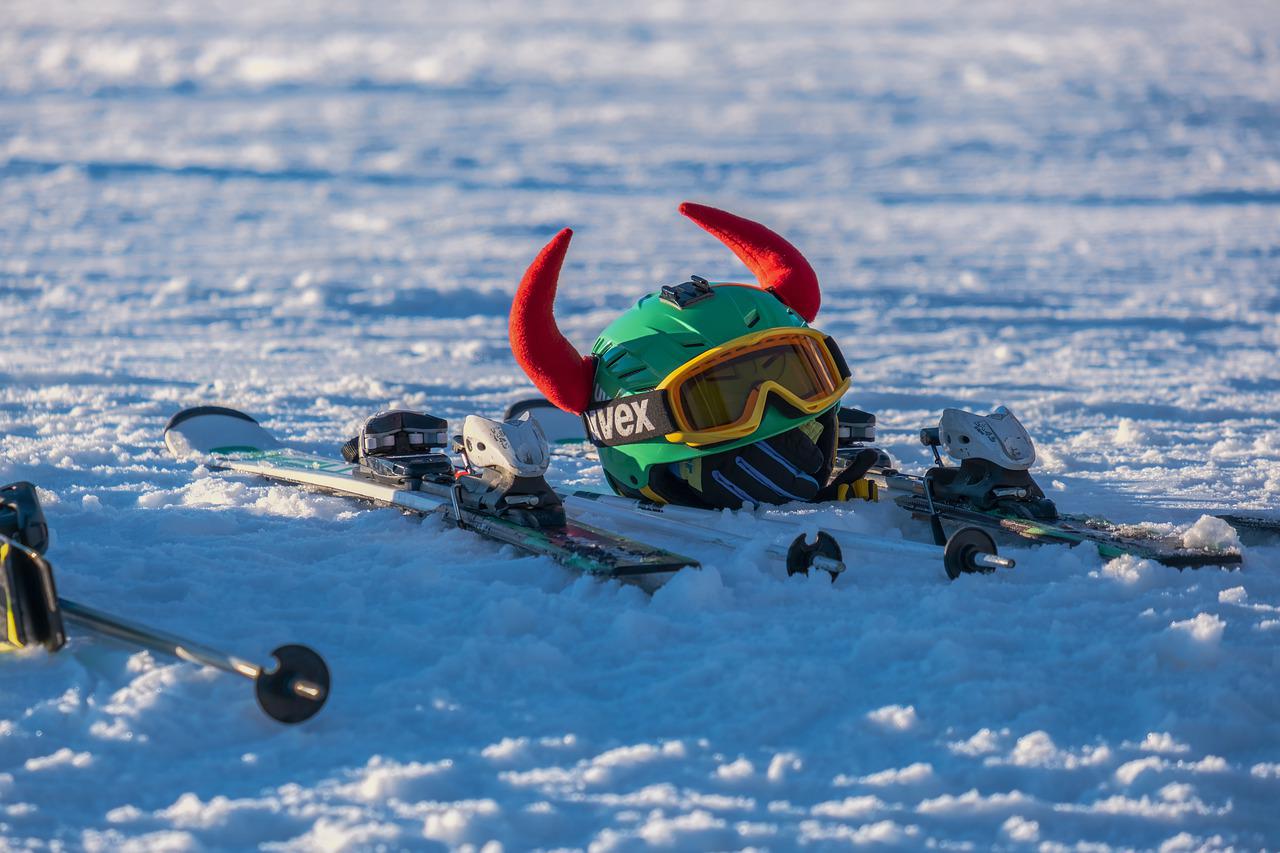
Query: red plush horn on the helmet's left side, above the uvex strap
[[508, 228, 595, 415]]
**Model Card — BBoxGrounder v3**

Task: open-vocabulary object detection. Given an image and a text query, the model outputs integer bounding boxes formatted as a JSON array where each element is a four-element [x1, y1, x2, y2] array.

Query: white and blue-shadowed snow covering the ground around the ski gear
[[0, 0, 1280, 852]]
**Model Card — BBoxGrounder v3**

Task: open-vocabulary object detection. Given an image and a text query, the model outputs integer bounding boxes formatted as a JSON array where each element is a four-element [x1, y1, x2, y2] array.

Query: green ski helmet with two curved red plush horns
[[511, 204, 847, 500]]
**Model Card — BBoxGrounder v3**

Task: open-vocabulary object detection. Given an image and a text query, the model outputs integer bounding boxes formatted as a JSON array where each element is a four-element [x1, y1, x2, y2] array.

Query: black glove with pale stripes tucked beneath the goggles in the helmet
[[677, 429, 831, 510]]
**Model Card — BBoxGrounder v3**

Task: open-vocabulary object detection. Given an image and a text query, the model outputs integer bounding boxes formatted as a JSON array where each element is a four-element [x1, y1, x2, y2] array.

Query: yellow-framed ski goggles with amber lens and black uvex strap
[[582, 328, 850, 447]]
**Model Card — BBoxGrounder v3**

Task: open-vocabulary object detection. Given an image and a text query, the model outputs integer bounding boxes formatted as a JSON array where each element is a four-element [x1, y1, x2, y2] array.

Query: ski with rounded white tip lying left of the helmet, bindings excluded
[[164, 406, 698, 578]]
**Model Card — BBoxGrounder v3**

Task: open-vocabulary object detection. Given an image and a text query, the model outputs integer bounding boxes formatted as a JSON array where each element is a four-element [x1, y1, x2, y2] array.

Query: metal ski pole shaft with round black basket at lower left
[[58, 598, 329, 722]]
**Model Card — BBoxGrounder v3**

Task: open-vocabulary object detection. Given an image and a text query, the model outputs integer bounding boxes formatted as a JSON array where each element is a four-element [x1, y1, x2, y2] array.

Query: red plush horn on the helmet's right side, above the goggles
[[680, 201, 822, 323]]
